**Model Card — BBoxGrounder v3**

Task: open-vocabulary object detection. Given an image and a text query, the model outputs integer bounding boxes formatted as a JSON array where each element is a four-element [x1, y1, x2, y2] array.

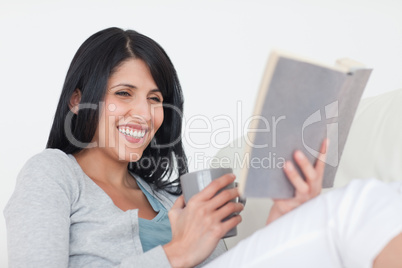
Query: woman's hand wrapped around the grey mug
[[163, 174, 244, 267]]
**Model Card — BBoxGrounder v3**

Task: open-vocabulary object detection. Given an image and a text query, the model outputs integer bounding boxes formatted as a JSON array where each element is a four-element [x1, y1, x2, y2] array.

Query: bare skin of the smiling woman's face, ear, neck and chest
[[70, 59, 163, 220]]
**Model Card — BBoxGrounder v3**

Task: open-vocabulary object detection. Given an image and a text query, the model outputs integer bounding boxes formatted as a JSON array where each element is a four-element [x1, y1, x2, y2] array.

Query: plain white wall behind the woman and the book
[[0, 0, 402, 267]]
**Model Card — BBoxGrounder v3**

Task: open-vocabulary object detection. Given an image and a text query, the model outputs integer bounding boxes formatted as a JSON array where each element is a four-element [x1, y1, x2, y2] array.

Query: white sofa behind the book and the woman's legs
[[216, 89, 402, 248]]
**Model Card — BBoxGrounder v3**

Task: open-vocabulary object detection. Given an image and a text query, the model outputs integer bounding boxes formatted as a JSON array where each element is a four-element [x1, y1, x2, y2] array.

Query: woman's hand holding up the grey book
[[267, 139, 328, 224]]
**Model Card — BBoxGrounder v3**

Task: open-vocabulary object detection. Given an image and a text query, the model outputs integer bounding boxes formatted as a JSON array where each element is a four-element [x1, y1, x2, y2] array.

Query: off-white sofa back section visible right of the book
[[334, 89, 402, 187]]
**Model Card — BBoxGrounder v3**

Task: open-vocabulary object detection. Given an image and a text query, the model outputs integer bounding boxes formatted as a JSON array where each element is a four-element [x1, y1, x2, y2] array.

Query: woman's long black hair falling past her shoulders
[[46, 28, 188, 194]]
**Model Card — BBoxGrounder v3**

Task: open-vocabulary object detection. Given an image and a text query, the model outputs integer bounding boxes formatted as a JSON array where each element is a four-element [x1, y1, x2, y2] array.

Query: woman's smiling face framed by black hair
[[94, 59, 163, 162]]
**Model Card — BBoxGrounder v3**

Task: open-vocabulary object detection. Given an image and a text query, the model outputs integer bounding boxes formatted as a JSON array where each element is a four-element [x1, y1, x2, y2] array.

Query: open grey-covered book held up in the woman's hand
[[239, 52, 371, 198]]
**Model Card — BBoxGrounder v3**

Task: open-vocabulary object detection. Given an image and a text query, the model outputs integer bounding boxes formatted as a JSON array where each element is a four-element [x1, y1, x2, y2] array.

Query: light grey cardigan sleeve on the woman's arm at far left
[[4, 156, 70, 267]]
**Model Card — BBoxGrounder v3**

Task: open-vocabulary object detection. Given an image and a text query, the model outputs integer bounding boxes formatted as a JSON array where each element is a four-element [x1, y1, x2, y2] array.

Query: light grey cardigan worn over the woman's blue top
[[4, 149, 226, 268]]
